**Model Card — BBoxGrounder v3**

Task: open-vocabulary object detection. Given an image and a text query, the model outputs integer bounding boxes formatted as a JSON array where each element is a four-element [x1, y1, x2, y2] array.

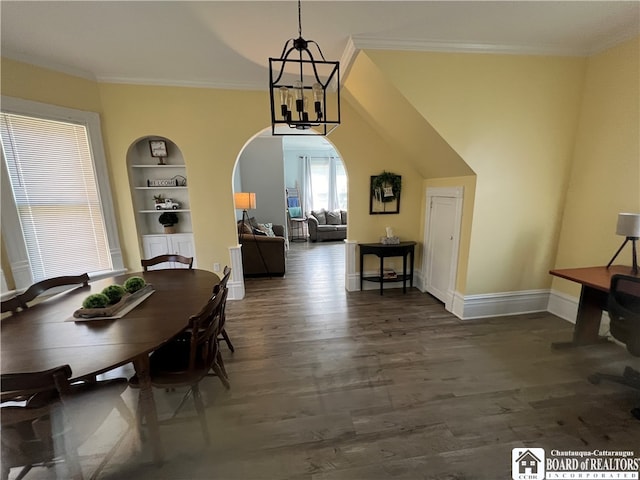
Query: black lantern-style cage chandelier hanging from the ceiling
[[269, 0, 340, 135]]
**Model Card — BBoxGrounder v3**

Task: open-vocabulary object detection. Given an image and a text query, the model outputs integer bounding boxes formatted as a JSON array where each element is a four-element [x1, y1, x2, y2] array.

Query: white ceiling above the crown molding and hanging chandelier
[[0, 0, 640, 89]]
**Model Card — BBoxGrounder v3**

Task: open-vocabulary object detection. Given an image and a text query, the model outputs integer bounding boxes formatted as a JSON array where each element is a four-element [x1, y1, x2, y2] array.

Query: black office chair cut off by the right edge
[[588, 275, 640, 420]]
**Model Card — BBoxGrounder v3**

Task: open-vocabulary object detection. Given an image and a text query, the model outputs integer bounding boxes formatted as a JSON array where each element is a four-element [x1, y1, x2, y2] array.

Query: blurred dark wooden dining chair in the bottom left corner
[[0, 365, 136, 480]]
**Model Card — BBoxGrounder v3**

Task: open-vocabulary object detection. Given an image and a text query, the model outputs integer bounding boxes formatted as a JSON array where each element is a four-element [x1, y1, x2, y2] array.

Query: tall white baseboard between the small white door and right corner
[[451, 290, 549, 320]]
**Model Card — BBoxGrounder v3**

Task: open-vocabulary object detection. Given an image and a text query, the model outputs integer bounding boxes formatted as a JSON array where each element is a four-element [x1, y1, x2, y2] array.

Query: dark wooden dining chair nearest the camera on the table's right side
[[129, 288, 229, 444]]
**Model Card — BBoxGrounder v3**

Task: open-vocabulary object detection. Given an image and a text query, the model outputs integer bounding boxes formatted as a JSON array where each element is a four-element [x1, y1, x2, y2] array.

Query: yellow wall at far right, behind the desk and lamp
[[553, 37, 640, 296]]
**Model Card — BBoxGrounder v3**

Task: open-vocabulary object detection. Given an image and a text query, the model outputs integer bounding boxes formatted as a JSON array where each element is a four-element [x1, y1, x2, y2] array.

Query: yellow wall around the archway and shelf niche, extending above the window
[[2, 59, 430, 278]]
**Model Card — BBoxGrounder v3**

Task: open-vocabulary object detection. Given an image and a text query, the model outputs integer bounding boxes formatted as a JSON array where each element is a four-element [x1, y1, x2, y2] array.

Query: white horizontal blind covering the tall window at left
[[0, 113, 112, 282]]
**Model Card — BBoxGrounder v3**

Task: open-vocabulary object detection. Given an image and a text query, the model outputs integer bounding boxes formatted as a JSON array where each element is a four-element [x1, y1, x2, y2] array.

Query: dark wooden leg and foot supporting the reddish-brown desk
[[552, 285, 608, 348]]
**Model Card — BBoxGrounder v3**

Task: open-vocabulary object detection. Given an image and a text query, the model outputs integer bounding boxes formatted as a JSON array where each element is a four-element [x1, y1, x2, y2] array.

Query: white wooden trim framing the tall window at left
[[0, 95, 125, 290]]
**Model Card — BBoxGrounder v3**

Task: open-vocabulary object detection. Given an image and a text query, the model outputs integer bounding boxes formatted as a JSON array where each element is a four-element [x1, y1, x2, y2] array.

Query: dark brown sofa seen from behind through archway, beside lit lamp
[[238, 218, 286, 277]]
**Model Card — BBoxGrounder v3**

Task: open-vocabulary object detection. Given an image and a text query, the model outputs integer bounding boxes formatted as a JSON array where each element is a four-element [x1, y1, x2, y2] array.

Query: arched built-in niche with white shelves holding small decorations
[[127, 136, 196, 266]]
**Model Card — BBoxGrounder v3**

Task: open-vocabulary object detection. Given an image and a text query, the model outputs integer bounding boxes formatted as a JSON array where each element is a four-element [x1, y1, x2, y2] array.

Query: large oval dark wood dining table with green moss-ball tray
[[0, 269, 220, 462]]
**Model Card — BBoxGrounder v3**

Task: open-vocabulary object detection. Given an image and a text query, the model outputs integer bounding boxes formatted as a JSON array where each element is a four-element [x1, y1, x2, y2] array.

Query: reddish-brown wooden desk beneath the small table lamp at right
[[549, 265, 631, 348]]
